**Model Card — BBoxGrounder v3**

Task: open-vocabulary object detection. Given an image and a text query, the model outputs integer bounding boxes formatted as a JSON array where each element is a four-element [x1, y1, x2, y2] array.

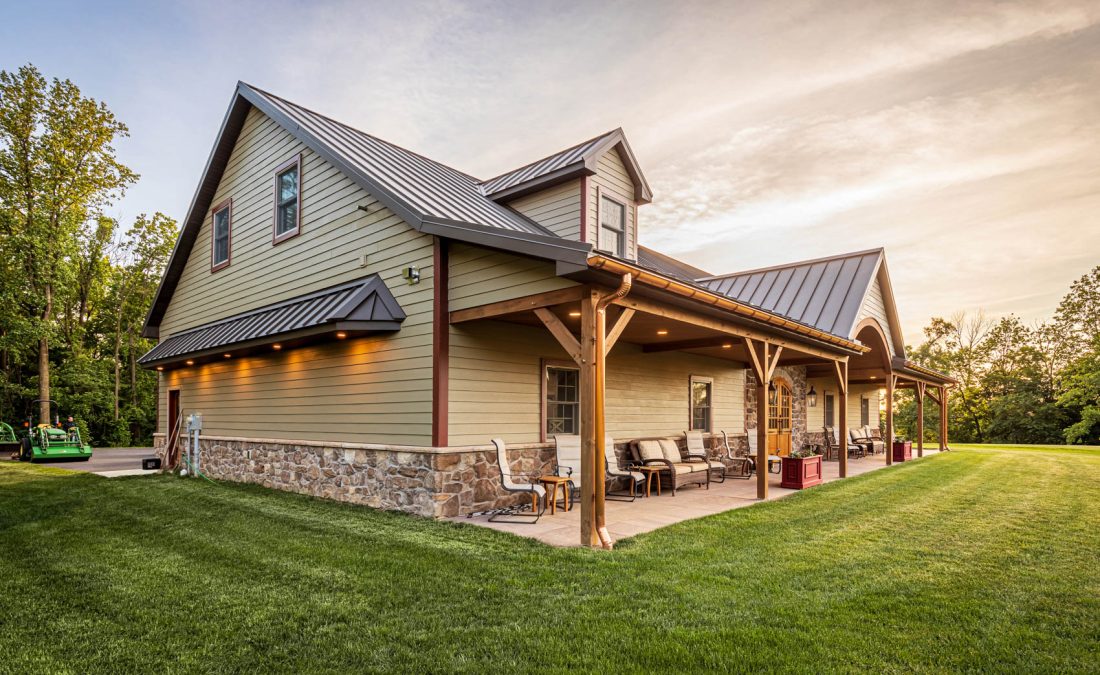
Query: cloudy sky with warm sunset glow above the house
[[0, 0, 1100, 343]]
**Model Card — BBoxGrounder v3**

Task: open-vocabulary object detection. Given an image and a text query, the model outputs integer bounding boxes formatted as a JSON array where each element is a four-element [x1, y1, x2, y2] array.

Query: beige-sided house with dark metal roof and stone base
[[141, 84, 950, 529]]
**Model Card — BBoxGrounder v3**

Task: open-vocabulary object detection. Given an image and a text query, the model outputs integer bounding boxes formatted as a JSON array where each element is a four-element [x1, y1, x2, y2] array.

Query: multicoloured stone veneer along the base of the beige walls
[[153, 433, 747, 518]]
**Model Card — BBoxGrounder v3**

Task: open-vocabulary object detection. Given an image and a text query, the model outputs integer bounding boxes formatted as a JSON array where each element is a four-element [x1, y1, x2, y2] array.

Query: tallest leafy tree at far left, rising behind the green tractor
[[0, 65, 138, 419]]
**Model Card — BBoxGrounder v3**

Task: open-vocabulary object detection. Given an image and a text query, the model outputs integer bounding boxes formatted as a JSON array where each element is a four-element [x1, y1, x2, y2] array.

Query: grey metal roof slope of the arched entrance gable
[[697, 248, 882, 338]]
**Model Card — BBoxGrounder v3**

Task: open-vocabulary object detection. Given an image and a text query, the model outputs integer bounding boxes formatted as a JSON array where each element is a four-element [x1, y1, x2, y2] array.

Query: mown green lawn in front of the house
[[0, 449, 1100, 673]]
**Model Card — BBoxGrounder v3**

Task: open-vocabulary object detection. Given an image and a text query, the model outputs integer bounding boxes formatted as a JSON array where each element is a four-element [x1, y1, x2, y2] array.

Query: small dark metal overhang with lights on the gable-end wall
[[139, 275, 405, 368]]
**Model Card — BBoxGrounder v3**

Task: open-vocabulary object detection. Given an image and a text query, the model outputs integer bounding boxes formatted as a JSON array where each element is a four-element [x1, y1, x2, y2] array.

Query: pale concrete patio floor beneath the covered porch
[[451, 449, 938, 546]]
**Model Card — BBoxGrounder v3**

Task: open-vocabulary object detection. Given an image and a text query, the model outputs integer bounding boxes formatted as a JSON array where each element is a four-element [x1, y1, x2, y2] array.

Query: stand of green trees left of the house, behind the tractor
[[0, 65, 177, 445]]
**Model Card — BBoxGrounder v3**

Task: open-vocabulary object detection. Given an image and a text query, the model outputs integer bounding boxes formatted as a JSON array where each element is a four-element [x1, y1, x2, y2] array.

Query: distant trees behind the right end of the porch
[[894, 266, 1100, 445]]
